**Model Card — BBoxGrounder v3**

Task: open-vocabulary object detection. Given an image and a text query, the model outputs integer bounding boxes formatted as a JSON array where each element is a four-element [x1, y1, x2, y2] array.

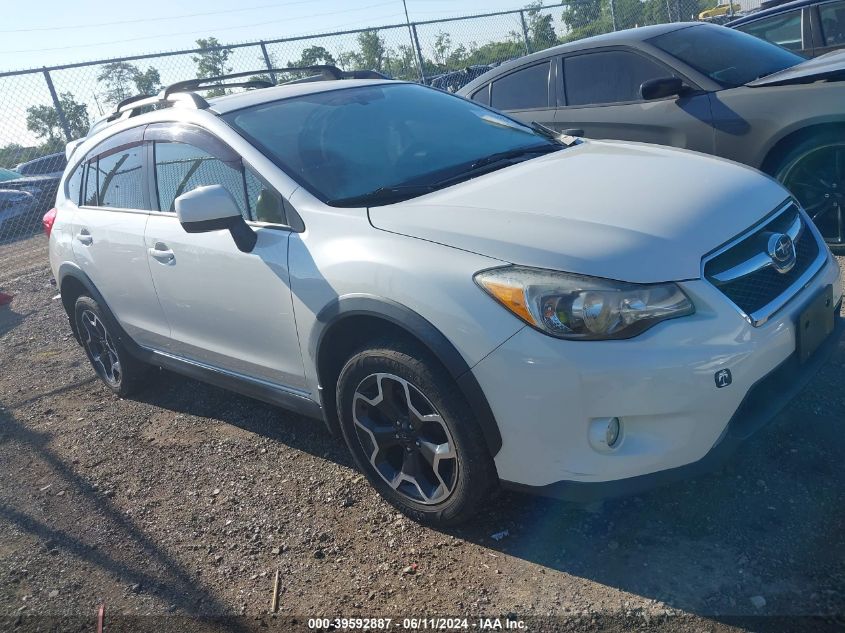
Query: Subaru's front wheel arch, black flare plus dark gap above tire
[[308, 295, 502, 456]]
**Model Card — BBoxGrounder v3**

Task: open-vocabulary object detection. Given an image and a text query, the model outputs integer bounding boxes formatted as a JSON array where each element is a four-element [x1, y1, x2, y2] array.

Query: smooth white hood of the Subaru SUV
[[369, 141, 789, 283]]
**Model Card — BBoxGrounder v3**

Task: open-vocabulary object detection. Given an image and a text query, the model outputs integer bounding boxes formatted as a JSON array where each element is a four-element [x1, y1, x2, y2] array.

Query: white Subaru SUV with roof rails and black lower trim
[[45, 68, 842, 525]]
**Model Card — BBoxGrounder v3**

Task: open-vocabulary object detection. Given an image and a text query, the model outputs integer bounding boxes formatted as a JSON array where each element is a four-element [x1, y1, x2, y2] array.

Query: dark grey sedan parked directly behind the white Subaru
[[458, 23, 845, 245]]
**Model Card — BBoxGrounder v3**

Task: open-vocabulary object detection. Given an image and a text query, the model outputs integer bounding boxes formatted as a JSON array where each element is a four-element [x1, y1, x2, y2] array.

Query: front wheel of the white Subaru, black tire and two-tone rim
[[337, 337, 498, 527]]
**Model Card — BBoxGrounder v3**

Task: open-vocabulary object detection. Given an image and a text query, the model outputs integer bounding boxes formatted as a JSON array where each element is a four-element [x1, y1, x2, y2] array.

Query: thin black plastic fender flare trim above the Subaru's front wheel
[[308, 294, 502, 457]]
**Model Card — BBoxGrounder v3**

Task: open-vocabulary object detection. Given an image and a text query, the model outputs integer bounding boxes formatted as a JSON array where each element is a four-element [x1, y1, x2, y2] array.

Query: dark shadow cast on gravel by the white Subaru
[[125, 368, 845, 631]]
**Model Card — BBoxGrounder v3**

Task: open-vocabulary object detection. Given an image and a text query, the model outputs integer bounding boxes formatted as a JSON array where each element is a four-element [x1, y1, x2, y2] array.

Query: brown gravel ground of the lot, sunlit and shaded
[[0, 237, 845, 631]]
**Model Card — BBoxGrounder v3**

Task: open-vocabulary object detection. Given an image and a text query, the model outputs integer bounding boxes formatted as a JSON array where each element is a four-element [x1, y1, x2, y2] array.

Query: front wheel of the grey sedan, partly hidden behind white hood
[[771, 130, 845, 247]]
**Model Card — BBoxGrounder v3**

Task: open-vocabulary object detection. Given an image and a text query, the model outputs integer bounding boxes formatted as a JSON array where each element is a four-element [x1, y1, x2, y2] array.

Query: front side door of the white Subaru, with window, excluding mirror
[[146, 124, 305, 389]]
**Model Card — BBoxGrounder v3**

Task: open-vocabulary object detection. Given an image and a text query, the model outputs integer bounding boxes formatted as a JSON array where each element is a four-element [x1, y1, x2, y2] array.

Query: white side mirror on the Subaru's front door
[[175, 185, 258, 253]]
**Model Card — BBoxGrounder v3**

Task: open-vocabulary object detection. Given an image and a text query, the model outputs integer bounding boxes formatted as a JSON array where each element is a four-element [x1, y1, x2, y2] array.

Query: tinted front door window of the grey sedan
[[563, 51, 672, 105]]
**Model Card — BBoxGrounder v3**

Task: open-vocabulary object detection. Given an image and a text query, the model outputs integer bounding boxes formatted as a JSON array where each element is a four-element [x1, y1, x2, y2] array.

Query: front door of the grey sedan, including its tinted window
[[554, 48, 713, 153]]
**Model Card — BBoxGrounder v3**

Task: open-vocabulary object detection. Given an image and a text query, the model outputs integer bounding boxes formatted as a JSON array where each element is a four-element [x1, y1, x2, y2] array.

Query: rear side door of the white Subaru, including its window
[[72, 127, 170, 348]]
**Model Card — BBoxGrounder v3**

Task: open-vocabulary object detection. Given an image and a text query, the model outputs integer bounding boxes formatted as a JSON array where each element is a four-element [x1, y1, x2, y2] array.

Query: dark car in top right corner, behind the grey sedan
[[725, 0, 845, 57]]
